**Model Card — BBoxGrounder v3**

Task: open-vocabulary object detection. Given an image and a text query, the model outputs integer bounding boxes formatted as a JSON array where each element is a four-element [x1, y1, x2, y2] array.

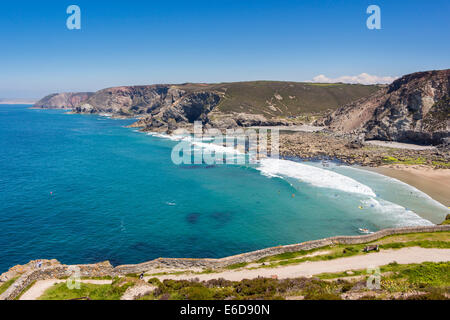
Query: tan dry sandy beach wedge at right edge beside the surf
[[366, 165, 450, 207]]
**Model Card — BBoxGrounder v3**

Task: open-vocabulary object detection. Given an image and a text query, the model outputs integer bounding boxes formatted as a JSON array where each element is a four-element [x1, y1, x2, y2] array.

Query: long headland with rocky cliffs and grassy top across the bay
[[74, 81, 379, 131]]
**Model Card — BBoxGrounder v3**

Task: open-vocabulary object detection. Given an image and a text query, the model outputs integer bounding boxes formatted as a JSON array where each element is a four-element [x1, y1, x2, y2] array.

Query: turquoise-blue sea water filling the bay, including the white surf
[[0, 105, 449, 272]]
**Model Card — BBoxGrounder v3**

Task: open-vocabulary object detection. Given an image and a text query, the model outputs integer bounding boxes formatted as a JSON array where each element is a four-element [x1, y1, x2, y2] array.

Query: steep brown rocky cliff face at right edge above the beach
[[325, 69, 450, 144]]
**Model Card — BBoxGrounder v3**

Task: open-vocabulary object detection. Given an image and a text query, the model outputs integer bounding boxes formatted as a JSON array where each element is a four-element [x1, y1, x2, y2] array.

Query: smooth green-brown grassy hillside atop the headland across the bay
[[172, 81, 380, 118]]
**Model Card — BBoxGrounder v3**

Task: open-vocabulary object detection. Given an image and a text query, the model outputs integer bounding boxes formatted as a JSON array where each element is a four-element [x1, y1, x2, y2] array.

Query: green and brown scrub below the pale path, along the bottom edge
[[138, 262, 450, 300]]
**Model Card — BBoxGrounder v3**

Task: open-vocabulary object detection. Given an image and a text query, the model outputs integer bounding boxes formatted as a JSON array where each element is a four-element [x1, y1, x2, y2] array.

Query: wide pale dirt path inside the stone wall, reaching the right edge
[[147, 247, 450, 281]]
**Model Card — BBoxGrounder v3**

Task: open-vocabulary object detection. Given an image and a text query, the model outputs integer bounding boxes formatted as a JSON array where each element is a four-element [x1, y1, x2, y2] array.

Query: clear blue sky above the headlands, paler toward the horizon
[[0, 0, 450, 98]]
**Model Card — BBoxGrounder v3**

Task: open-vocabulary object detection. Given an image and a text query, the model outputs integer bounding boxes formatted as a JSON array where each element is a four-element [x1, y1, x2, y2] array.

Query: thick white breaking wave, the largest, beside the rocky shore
[[256, 159, 376, 197]]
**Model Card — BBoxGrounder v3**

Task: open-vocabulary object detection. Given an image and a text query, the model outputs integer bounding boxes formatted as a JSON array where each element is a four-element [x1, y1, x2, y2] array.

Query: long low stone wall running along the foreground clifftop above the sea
[[0, 225, 450, 300]]
